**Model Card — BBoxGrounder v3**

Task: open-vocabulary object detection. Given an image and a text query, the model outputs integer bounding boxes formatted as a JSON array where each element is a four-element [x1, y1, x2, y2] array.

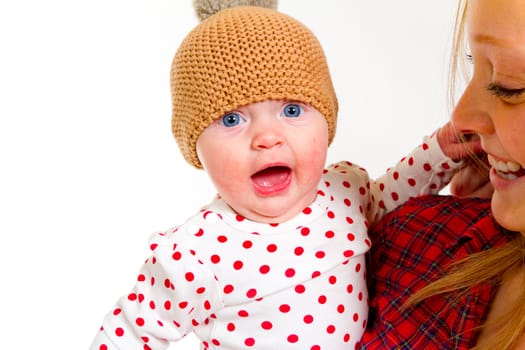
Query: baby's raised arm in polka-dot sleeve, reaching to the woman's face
[[367, 123, 470, 224]]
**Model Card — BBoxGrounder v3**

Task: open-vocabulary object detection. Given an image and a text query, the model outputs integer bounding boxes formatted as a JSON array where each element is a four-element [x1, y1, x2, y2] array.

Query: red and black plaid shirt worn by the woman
[[360, 195, 515, 350]]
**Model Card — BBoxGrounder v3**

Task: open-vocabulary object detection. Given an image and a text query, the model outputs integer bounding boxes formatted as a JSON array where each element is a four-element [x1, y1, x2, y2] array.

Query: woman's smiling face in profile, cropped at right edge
[[452, 0, 525, 232]]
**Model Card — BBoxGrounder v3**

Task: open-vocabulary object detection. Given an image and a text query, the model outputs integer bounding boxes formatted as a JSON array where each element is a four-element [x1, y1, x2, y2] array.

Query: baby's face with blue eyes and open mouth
[[197, 100, 328, 223]]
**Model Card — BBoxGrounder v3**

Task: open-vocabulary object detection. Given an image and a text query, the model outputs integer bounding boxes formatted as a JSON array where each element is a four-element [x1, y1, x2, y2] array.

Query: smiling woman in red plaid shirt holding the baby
[[361, 0, 525, 349]]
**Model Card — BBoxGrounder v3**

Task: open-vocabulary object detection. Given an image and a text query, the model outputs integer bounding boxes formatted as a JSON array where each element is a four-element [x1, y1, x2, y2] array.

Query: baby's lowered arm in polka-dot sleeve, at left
[[90, 234, 221, 350]]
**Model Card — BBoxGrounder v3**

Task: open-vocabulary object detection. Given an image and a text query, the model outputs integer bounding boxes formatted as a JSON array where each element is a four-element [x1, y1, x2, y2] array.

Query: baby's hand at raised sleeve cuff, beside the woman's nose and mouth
[[437, 122, 483, 161]]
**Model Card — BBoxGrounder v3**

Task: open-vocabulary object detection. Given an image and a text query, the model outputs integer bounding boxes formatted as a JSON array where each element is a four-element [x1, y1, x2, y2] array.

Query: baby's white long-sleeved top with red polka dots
[[91, 133, 459, 350]]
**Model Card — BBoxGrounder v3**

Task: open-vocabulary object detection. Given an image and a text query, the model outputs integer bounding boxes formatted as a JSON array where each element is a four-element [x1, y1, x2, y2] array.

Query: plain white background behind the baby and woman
[[0, 0, 456, 349]]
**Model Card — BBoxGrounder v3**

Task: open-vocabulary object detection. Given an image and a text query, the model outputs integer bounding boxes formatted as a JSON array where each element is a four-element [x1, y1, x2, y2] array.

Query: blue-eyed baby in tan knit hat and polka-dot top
[[91, 6, 470, 350]]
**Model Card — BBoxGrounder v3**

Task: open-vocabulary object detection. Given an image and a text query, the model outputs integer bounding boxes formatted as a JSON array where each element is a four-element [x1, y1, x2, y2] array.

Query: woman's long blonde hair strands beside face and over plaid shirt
[[405, 0, 525, 349]]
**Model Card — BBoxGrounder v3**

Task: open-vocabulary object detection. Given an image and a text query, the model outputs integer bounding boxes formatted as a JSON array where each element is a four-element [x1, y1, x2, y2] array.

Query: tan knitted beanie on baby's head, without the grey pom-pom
[[170, 1, 338, 168]]
